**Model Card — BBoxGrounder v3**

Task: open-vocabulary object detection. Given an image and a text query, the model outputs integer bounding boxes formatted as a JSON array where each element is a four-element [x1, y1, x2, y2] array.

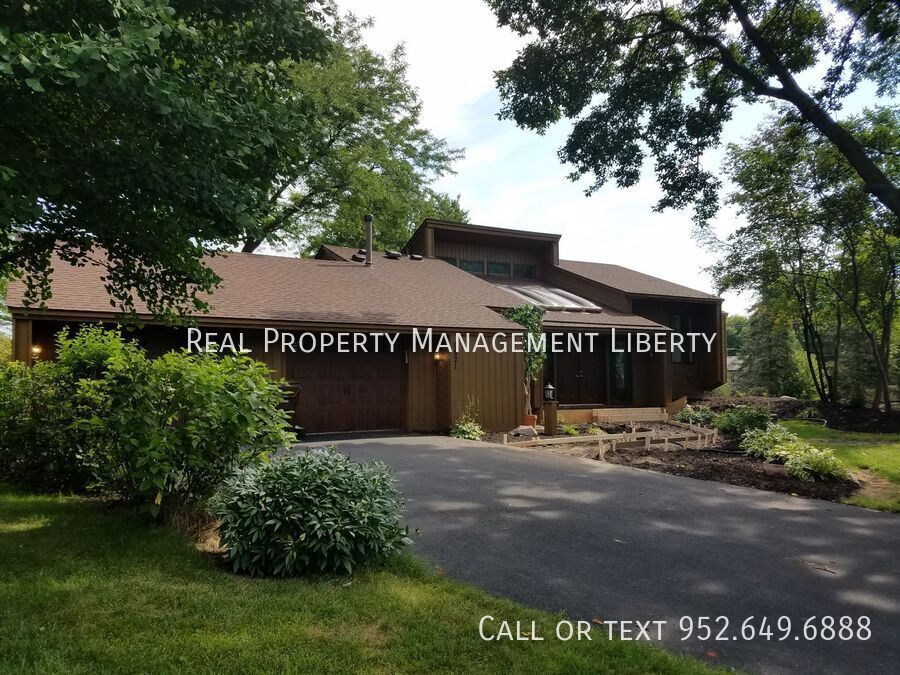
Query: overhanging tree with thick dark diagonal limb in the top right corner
[[488, 0, 900, 231]]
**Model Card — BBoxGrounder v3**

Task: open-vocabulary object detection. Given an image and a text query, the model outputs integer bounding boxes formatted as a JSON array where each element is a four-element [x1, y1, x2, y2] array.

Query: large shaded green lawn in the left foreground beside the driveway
[[0, 490, 705, 673]]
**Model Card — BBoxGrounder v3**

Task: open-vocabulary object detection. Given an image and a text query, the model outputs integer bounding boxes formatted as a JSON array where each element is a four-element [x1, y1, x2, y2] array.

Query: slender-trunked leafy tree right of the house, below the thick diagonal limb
[[713, 108, 900, 411]]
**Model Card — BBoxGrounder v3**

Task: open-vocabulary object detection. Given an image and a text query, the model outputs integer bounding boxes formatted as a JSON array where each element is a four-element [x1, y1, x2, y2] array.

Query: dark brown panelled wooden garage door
[[286, 352, 406, 433]]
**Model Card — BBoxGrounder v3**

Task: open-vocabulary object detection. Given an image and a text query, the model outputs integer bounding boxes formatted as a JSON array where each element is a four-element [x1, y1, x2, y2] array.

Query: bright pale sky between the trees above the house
[[338, 0, 884, 314]]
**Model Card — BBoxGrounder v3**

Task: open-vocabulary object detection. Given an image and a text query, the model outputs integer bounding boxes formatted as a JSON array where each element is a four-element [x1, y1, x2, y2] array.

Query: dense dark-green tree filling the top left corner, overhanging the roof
[[0, 0, 331, 314]]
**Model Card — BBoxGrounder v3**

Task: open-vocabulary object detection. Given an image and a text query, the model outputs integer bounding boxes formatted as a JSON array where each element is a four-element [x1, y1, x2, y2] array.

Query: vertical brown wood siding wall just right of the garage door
[[448, 344, 525, 431]]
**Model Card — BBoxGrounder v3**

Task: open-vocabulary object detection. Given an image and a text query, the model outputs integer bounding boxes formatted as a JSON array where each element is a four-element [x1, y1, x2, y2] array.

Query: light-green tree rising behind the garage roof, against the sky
[[243, 16, 466, 253]]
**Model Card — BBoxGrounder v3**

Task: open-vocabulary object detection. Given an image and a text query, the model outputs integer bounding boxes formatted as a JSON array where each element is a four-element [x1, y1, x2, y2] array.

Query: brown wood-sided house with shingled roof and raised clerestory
[[8, 219, 725, 433]]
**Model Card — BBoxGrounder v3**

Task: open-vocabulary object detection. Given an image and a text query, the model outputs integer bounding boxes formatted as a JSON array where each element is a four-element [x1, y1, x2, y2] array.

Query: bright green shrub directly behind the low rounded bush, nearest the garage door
[[98, 351, 294, 515]]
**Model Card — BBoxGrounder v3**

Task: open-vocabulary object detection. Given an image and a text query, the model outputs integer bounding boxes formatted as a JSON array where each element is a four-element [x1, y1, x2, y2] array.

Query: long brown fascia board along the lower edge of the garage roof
[[10, 307, 524, 334]]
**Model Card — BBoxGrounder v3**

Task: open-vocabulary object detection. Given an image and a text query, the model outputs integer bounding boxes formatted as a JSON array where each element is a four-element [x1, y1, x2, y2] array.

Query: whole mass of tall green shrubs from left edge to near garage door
[[0, 327, 291, 515]]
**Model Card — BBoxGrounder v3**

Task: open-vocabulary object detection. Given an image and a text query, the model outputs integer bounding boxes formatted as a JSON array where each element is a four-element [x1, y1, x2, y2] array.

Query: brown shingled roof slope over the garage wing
[[7, 253, 519, 330]]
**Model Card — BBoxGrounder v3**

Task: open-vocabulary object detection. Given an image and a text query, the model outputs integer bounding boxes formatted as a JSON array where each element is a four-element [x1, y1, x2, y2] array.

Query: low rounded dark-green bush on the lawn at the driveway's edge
[[211, 448, 410, 576]]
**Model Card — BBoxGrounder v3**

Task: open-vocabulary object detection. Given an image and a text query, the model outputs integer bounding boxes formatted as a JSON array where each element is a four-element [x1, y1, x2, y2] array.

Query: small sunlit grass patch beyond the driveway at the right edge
[[781, 420, 900, 513]]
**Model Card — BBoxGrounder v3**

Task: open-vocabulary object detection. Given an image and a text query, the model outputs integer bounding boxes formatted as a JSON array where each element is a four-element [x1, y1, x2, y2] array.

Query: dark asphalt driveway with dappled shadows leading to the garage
[[292, 436, 900, 673]]
